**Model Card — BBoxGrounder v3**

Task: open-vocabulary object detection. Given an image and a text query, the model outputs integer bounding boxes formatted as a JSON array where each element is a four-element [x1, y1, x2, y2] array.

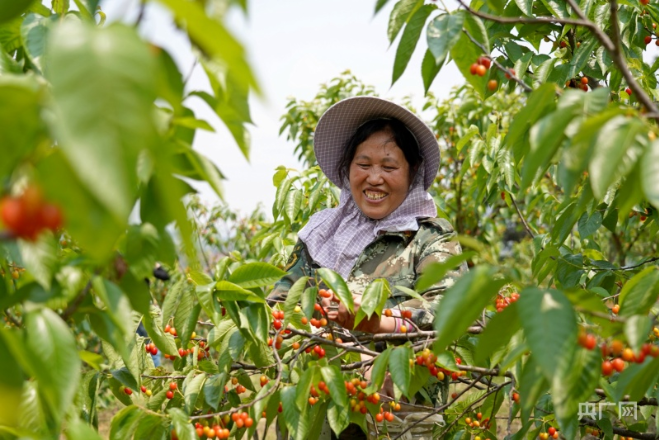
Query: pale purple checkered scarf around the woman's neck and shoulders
[[298, 166, 437, 278]]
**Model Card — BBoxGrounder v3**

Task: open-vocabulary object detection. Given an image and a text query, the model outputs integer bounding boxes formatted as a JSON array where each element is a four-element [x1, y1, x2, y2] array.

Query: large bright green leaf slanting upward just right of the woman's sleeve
[[435, 266, 506, 353]]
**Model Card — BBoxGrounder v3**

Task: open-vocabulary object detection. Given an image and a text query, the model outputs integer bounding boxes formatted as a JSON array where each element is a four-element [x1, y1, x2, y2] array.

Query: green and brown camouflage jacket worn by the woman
[[269, 218, 467, 330]]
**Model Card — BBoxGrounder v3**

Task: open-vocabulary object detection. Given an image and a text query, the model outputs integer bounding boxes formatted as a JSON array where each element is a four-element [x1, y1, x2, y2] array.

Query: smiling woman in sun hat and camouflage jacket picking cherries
[[270, 96, 466, 333]]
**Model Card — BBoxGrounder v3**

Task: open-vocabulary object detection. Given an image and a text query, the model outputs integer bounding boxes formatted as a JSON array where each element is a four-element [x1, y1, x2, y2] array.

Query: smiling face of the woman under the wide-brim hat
[[349, 131, 410, 220]]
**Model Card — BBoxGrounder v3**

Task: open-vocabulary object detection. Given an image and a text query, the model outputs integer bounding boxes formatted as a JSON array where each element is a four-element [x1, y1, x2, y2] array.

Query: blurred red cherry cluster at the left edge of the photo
[[0, 186, 63, 241]]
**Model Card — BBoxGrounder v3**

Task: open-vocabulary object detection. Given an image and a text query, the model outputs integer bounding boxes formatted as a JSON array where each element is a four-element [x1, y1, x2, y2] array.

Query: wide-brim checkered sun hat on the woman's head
[[313, 96, 439, 189]]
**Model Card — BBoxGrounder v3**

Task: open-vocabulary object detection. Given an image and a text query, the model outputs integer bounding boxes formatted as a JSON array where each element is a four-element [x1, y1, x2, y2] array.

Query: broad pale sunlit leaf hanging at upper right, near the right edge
[[588, 116, 645, 200]]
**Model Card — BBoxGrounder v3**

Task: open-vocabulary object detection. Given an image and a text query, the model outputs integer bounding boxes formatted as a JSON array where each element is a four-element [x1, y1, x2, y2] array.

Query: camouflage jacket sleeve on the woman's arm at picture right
[[400, 219, 467, 330]]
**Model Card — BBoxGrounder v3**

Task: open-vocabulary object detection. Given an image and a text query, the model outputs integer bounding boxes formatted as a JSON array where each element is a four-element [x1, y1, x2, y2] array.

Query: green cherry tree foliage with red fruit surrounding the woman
[[0, 0, 659, 439]]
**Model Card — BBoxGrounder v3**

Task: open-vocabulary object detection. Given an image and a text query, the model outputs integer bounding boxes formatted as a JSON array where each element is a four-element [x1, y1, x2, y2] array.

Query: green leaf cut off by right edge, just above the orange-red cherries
[[619, 267, 659, 316]]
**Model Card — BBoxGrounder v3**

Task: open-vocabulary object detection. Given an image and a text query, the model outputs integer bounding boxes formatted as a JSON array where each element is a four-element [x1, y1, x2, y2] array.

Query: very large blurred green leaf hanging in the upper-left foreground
[[46, 20, 157, 225]]
